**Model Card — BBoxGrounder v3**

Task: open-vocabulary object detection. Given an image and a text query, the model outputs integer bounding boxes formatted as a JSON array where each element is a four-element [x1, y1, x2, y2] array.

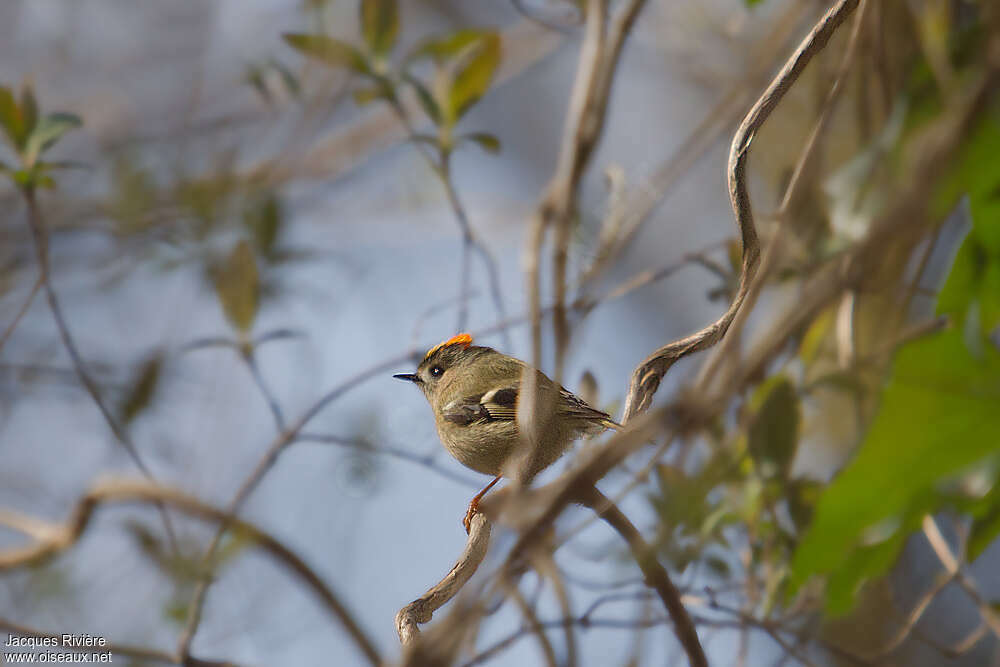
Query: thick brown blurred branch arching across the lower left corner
[[0, 479, 380, 665]]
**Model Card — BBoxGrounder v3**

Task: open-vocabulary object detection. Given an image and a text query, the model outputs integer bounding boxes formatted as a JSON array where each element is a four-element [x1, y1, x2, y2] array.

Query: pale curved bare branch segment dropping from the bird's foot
[[396, 513, 490, 655]]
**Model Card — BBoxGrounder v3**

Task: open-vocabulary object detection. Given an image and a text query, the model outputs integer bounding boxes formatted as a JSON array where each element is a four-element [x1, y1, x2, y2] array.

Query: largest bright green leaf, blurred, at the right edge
[[791, 329, 1000, 612]]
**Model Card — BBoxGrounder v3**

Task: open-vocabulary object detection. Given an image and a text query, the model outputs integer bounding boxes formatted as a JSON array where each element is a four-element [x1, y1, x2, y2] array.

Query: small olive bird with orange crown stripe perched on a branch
[[393, 333, 621, 533]]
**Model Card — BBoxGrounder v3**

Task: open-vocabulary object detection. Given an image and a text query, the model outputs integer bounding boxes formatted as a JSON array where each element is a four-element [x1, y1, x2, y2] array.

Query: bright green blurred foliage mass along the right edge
[[792, 107, 1000, 613]]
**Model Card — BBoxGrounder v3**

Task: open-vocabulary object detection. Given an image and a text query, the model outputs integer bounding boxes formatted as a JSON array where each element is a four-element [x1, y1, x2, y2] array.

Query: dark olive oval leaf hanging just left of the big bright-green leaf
[[748, 375, 801, 477]]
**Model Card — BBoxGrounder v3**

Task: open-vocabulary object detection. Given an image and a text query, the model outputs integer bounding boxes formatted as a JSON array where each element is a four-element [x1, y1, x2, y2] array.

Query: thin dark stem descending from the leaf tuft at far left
[[24, 187, 178, 553]]
